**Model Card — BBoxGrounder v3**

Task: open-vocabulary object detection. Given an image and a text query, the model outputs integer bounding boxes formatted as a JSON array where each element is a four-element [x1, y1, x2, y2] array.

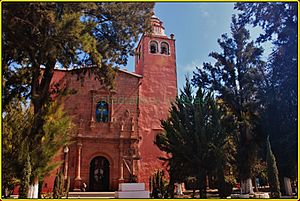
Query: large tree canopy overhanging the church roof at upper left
[[2, 2, 153, 96]]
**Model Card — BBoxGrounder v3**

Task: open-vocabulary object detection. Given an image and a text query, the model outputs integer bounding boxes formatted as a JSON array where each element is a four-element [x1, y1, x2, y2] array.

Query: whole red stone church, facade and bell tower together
[[44, 16, 177, 191]]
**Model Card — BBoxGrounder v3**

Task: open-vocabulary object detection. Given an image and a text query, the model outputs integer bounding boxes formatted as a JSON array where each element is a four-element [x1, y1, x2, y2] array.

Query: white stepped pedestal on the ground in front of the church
[[116, 183, 150, 198]]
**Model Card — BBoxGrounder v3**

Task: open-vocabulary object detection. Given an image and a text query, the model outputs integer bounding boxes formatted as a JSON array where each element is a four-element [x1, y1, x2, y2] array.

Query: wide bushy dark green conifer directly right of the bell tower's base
[[155, 79, 234, 198]]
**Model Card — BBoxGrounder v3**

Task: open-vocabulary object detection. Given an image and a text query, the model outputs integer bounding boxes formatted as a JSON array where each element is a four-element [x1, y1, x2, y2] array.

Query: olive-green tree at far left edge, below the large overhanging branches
[[2, 102, 33, 198]]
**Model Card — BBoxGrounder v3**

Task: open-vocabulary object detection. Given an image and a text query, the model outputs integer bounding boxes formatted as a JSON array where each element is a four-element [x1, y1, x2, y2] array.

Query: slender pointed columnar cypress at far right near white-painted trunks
[[267, 136, 281, 198]]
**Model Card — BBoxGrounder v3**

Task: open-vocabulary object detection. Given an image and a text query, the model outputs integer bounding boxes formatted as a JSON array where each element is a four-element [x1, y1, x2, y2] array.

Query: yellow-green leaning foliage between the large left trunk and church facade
[[30, 101, 76, 197]]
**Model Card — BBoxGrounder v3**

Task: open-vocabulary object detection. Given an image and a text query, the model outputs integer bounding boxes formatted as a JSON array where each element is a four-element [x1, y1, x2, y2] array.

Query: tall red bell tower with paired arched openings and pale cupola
[[135, 15, 177, 184]]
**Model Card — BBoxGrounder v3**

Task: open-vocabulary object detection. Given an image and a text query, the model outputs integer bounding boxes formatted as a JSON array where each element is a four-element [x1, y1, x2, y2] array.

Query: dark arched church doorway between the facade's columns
[[89, 156, 109, 192]]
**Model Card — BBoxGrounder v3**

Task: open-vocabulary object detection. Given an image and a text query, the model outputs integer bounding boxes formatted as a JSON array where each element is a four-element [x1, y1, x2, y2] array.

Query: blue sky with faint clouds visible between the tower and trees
[[127, 2, 270, 92]]
